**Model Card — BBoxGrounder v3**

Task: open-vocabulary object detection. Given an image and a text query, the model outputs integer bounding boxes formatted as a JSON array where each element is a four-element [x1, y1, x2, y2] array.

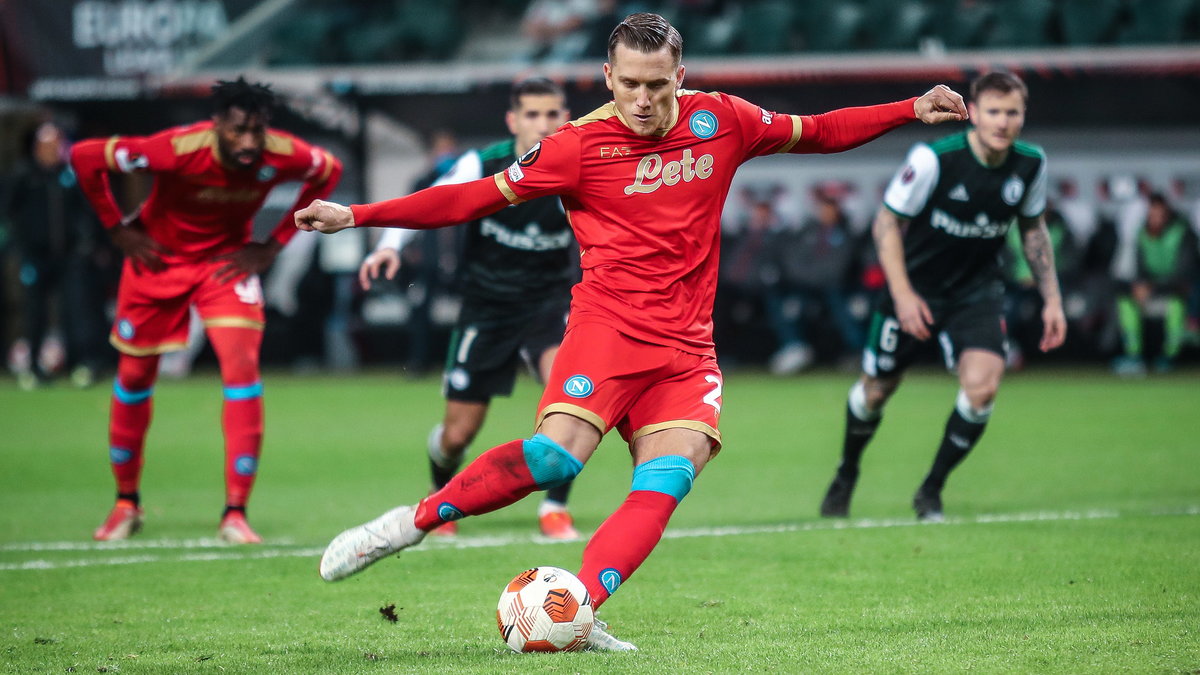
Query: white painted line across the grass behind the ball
[[0, 506, 1200, 572]]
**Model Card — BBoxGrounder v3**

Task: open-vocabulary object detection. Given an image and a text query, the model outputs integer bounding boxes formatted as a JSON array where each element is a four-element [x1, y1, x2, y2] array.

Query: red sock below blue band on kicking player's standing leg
[[580, 490, 679, 609]]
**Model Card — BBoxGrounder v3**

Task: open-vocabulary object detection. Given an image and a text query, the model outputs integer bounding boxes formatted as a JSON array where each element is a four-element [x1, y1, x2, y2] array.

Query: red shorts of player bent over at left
[[108, 261, 264, 357]]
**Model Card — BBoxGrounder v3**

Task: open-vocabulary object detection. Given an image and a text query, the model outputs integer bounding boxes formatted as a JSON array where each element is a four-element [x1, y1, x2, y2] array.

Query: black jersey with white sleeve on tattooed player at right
[[883, 132, 1046, 300]]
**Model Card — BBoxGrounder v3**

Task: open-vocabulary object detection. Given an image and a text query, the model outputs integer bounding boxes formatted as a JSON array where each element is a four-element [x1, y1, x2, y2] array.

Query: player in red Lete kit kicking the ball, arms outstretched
[[296, 13, 966, 650]]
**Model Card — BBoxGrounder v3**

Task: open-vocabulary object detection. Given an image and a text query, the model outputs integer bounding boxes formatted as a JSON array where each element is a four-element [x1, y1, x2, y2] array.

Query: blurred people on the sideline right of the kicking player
[[715, 177, 1200, 375]]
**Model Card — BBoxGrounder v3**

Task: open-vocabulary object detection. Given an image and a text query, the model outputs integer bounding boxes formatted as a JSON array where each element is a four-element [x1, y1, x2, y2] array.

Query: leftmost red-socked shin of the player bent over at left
[[108, 354, 158, 497]]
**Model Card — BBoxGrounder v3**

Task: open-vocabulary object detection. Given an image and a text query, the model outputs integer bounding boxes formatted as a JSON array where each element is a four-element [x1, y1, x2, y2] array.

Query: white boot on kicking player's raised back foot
[[320, 506, 425, 581]]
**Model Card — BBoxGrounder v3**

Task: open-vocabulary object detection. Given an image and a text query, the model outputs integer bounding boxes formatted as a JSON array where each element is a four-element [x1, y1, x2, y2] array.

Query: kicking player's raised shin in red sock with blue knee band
[[416, 434, 583, 531]]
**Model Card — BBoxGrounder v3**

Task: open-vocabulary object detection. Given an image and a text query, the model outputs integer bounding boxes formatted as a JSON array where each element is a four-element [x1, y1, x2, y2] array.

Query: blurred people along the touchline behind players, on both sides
[[0, 121, 1200, 388]]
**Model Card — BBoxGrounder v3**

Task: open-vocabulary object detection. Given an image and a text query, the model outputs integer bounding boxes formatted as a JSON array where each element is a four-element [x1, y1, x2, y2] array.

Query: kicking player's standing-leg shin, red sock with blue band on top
[[578, 455, 696, 608]]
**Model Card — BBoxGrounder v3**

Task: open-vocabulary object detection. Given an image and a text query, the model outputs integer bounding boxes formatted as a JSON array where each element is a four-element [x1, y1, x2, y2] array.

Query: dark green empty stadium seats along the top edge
[[263, 0, 1200, 65]]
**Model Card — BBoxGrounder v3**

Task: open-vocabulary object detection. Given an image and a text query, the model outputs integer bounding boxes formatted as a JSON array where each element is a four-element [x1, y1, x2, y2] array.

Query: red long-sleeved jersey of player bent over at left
[[71, 121, 342, 262]]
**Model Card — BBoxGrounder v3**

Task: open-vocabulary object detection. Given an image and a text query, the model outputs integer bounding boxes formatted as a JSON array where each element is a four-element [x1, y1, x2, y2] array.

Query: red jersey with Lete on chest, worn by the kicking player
[[496, 90, 802, 354]]
